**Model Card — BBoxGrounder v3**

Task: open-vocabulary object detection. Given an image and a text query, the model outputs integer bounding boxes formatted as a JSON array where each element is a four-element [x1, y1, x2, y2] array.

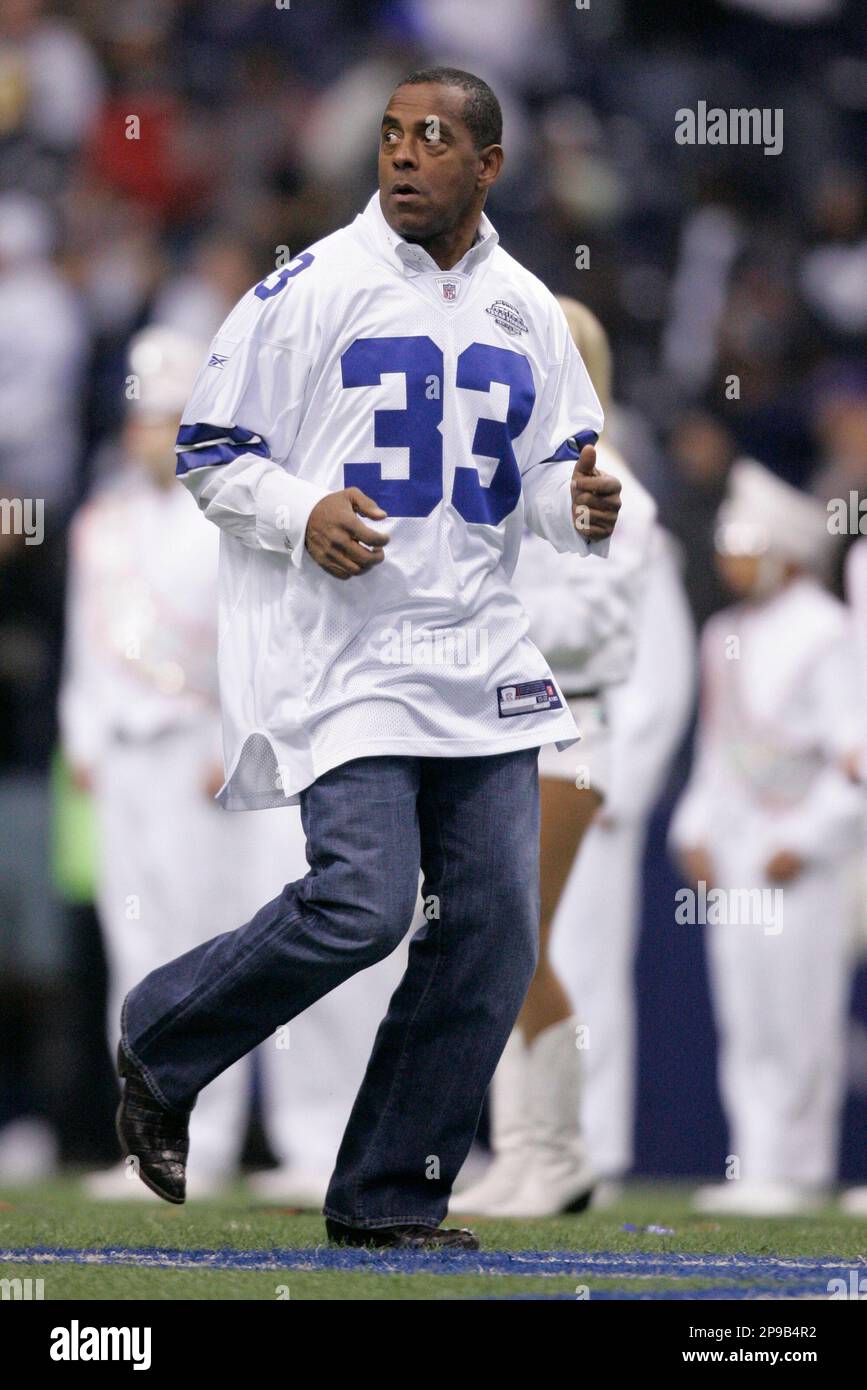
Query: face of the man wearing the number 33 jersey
[[379, 82, 497, 242]]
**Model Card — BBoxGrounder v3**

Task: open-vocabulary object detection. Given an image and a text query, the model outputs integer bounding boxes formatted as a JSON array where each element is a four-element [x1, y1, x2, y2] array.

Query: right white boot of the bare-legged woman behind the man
[[499, 1019, 595, 1216]]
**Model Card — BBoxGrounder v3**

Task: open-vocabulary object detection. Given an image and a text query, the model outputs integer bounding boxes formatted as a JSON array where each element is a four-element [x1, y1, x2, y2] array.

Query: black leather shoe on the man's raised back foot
[[115, 1044, 190, 1204]]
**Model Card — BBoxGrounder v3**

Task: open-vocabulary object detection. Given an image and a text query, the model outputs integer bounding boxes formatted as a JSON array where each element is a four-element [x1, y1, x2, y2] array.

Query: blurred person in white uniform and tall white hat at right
[[670, 459, 864, 1216]]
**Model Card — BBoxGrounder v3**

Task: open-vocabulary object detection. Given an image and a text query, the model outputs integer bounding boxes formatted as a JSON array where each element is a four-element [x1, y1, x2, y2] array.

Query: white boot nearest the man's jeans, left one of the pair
[[449, 1029, 532, 1216]]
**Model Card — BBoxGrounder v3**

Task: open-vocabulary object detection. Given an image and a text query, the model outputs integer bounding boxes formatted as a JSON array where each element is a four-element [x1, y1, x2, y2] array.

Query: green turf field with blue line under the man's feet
[[0, 1179, 867, 1300]]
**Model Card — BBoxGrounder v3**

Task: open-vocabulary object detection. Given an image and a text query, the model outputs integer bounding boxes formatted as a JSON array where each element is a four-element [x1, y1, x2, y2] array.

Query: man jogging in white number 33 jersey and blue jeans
[[118, 68, 620, 1248]]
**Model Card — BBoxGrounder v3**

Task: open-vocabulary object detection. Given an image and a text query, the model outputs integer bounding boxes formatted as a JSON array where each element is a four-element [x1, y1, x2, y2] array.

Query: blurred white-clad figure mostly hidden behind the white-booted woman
[[550, 524, 696, 1207]]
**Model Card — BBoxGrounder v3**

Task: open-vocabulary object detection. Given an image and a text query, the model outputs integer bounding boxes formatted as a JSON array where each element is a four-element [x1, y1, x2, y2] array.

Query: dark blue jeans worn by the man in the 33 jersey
[[122, 748, 539, 1227]]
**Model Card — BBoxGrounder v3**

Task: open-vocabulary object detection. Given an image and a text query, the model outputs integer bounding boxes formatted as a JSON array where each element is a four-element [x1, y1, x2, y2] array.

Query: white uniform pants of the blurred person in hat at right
[[708, 847, 856, 1187]]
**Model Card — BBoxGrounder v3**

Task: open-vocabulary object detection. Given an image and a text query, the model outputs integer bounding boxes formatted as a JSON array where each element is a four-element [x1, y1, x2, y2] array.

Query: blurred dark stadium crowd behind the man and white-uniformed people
[[0, 0, 867, 1176]]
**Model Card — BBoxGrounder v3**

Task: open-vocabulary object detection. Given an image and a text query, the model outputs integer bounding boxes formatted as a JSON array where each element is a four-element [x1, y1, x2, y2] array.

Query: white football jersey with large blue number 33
[[178, 195, 607, 809]]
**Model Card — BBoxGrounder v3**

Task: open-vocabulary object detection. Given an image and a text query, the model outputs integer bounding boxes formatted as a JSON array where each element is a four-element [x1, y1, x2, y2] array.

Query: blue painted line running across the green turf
[[0, 1245, 867, 1300]]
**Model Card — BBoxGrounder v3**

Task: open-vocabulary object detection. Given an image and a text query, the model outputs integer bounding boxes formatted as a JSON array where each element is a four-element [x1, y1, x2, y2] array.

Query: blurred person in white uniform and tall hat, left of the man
[[60, 328, 247, 1197]]
